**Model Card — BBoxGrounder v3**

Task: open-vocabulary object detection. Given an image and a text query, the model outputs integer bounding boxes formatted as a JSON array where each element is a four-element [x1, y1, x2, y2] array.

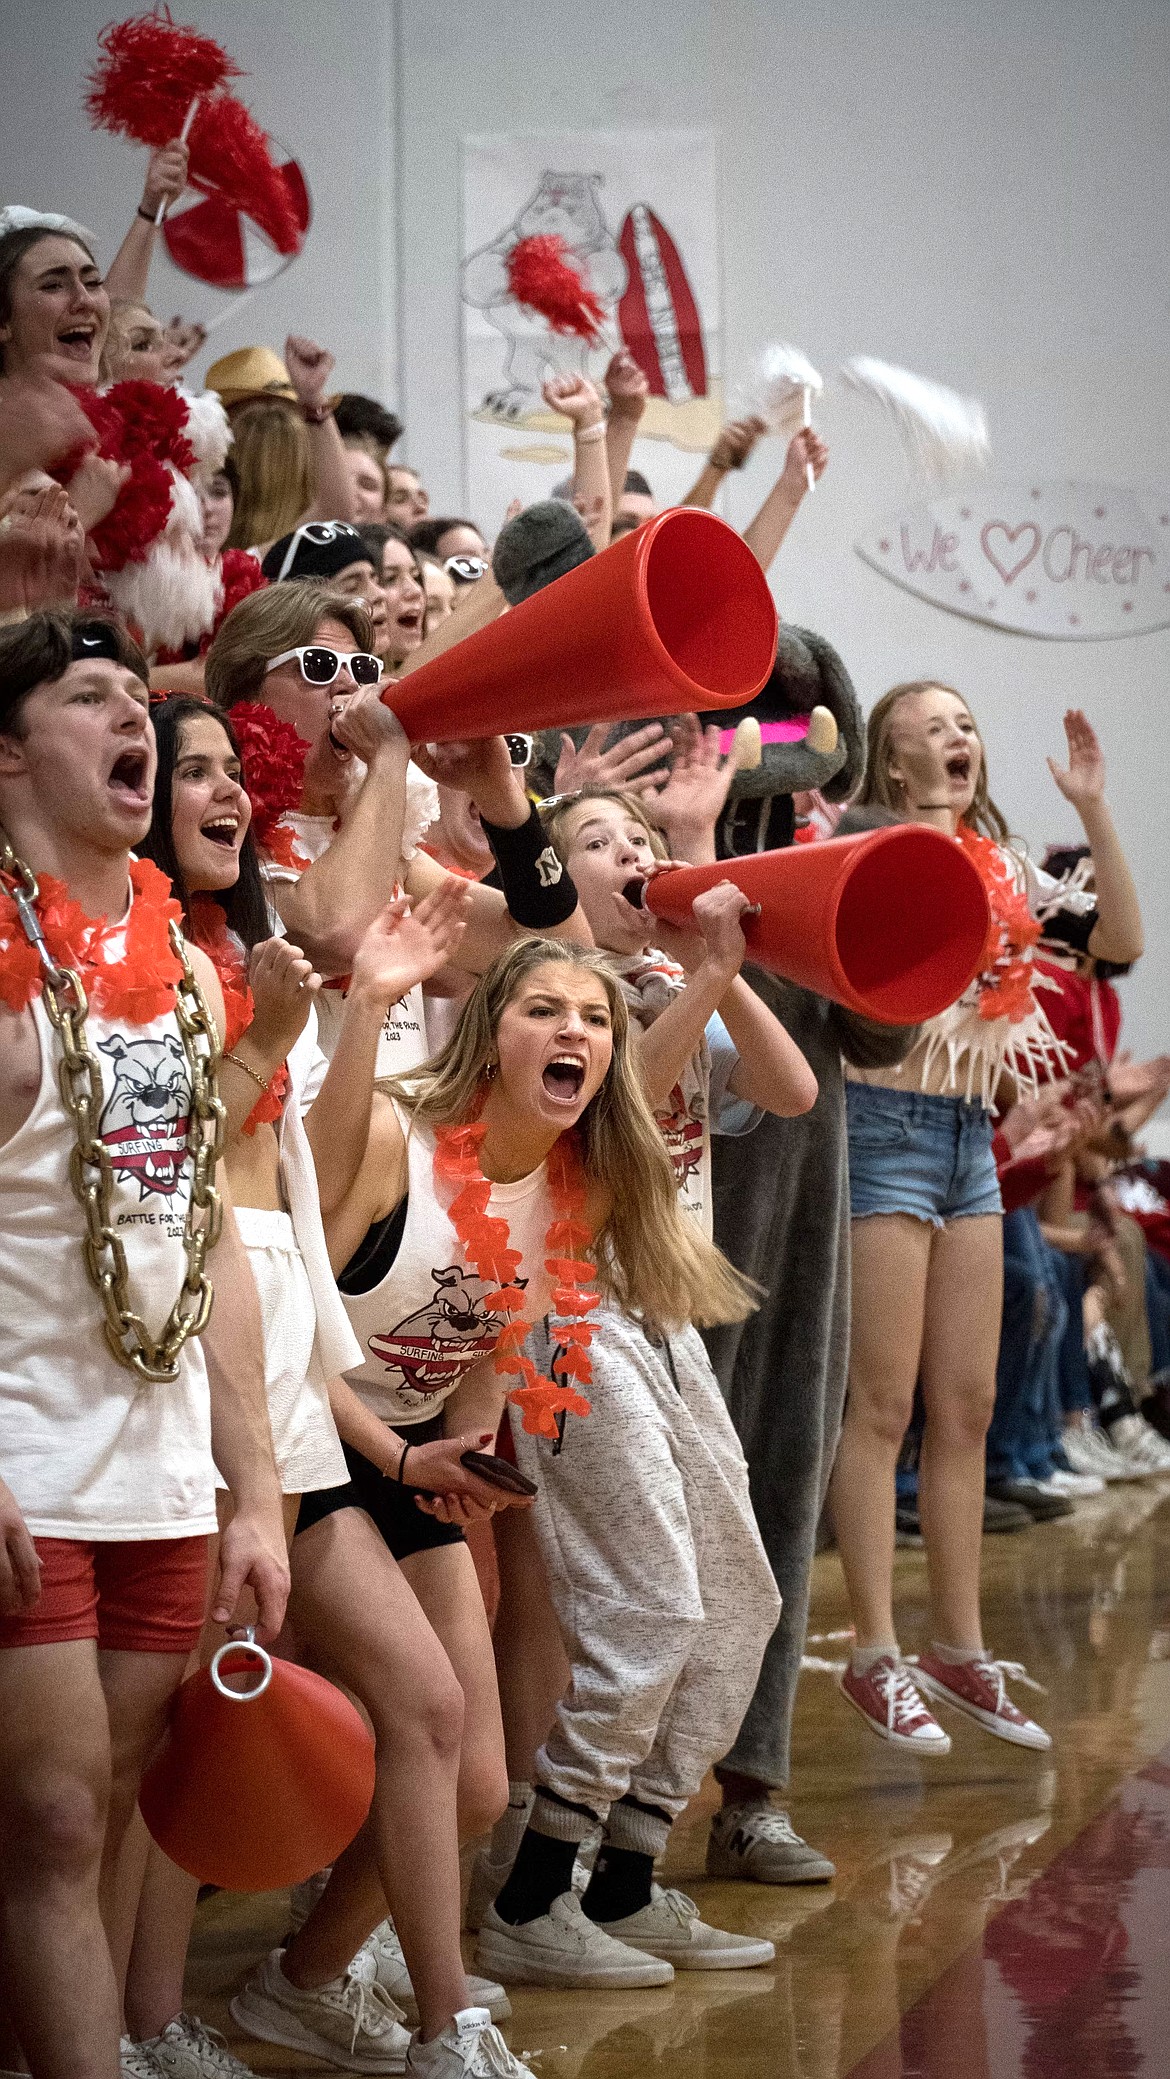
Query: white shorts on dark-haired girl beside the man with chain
[[232, 1206, 349, 1495]]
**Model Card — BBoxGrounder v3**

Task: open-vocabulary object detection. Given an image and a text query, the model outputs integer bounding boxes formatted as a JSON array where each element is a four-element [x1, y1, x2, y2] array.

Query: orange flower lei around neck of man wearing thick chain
[[0, 859, 183, 1025]]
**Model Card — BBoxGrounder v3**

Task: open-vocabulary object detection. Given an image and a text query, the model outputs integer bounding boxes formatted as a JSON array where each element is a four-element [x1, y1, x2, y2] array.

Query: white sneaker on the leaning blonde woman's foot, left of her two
[[231, 1950, 409, 2073]]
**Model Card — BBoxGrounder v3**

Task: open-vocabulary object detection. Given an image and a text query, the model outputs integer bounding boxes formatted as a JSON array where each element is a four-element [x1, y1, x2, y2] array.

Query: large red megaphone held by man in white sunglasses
[[382, 507, 777, 744]]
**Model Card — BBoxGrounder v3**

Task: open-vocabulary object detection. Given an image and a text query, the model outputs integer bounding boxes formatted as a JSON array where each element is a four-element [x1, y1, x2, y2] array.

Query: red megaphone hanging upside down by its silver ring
[[139, 1638, 374, 1892]]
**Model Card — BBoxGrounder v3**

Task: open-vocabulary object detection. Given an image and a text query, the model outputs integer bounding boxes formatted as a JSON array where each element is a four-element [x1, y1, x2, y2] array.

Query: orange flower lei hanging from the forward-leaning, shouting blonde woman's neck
[[434, 1123, 601, 1439]]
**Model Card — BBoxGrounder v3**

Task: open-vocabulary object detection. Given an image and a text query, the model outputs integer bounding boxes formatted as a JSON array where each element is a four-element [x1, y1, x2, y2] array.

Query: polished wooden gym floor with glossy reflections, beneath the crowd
[[189, 1482, 1170, 2079]]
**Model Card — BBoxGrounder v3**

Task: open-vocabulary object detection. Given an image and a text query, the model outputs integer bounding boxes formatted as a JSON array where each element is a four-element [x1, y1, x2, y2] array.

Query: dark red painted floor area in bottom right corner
[[850, 1746, 1170, 2079]]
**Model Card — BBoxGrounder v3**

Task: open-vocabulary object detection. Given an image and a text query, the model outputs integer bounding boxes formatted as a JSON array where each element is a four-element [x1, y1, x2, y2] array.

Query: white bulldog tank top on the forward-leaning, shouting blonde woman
[[343, 1104, 553, 1428]]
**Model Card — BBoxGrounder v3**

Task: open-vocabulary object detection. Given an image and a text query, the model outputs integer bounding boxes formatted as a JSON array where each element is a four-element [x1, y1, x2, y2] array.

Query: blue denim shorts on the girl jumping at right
[[846, 1083, 1004, 1227]]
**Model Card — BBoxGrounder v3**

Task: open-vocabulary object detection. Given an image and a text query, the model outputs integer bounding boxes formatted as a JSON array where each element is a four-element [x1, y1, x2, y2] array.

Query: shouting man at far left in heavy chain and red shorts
[[0, 613, 289, 2079]]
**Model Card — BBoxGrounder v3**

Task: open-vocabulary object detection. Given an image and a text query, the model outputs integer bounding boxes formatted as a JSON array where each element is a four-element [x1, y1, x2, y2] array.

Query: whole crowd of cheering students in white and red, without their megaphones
[[0, 143, 1170, 2079]]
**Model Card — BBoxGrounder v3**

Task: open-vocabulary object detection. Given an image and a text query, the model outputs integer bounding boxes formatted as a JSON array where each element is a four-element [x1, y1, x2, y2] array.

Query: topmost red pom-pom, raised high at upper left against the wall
[[85, 8, 239, 146]]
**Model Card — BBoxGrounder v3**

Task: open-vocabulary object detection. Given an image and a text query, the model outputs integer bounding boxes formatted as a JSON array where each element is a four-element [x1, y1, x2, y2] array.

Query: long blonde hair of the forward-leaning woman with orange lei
[[390, 938, 756, 1328]]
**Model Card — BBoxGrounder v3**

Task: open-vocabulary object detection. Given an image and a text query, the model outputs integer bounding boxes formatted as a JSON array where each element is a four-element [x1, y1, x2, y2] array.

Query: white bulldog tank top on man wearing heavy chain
[[0, 977, 216, 1543]]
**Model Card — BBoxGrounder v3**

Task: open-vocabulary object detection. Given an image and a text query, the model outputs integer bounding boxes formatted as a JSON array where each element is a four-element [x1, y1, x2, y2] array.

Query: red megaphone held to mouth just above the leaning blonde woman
[[628, 823, 991, 1025]]
